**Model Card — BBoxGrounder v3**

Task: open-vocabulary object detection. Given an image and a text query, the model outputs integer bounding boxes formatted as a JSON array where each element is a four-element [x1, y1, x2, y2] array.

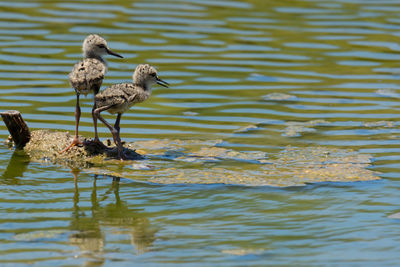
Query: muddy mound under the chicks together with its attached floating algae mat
[[7, 131, 380, 186]]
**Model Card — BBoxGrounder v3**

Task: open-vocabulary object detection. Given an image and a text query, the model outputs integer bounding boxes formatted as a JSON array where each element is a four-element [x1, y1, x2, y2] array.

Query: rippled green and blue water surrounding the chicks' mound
[[0, 0, 400, 266]]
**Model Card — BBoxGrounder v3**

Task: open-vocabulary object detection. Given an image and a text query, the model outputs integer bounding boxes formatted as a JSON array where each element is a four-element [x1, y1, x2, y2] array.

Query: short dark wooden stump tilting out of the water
[[0, 110, 31, 149]]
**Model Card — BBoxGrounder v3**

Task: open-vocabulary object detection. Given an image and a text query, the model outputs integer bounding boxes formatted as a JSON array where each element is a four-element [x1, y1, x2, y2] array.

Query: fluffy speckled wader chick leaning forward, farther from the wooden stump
[[94, 64, 169, 160]]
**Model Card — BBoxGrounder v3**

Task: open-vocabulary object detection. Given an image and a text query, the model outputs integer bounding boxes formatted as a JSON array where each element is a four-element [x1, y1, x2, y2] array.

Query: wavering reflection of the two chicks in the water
[[69, 170, 157, 265]]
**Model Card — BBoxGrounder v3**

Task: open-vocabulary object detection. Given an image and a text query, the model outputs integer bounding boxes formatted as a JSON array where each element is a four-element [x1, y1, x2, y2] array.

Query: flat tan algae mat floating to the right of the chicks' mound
[[87, 140, 380, 186]]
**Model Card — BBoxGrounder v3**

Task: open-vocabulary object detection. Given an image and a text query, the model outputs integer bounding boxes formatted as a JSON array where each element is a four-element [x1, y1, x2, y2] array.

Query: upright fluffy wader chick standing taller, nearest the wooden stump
[[61, 34, 123, 153]]
